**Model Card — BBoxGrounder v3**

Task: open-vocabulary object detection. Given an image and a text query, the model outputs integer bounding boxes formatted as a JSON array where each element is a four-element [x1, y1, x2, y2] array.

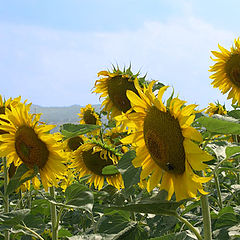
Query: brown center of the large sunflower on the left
[[15, 126, 49, 169]]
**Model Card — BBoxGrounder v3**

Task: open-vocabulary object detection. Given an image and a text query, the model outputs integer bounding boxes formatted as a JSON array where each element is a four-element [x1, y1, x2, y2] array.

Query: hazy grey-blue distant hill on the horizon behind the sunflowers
[[31, 104, 101, 126]]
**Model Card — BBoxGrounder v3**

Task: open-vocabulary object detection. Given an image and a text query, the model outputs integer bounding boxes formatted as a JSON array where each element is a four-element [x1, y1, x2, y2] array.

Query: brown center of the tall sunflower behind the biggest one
[[108, 76, 138, 113]]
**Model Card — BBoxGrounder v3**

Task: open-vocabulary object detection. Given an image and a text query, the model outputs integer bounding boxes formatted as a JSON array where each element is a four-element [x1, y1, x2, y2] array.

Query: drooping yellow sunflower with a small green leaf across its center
[[72, 143, 124, 190]]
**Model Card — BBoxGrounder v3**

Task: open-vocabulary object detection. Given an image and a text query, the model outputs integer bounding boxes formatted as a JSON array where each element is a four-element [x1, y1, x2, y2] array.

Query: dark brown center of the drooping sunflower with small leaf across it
[[82, 149, 116, 176]]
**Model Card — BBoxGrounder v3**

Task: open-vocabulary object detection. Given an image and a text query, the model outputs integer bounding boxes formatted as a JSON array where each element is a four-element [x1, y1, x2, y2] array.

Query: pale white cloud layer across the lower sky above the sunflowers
[[0, 16, 236, 106]]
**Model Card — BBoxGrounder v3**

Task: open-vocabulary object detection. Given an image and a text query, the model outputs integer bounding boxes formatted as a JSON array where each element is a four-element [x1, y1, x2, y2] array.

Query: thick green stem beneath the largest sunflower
[[201, 195, 212, 240]]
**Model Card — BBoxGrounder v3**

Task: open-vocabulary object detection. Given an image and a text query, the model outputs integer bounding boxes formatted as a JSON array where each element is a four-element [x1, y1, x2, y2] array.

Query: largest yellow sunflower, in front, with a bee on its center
[[116, 81, 212, 201]]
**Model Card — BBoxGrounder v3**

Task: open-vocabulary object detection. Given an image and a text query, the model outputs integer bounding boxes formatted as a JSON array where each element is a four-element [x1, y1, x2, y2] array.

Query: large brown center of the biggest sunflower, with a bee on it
[[143, 106, 185, 174]]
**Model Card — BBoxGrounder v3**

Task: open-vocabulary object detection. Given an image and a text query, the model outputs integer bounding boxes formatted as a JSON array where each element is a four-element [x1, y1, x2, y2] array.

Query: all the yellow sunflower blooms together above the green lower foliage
[[0, 39, 240, 240]]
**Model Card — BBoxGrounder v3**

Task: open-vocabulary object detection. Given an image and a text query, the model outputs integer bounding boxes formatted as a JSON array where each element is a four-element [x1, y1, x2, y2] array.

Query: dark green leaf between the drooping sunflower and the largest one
[[118, 150, 141, 188]]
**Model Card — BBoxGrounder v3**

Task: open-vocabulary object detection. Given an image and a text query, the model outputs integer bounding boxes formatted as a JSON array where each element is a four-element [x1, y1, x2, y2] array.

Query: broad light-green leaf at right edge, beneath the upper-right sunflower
[[196, 115, 240, 134]]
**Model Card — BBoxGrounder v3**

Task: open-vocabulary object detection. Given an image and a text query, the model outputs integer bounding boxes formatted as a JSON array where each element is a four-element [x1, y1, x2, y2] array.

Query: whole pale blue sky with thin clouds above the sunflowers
[[0, 0, 240, 107]]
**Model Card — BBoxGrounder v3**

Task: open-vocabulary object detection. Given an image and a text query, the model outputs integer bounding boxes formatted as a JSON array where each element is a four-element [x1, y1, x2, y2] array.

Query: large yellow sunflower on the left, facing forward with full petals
[[0, 103, 65, 191]]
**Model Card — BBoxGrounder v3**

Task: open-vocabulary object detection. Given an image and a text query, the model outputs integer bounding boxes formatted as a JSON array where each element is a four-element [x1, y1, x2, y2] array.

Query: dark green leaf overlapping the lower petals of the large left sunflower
[[6, 164, 38, 195]]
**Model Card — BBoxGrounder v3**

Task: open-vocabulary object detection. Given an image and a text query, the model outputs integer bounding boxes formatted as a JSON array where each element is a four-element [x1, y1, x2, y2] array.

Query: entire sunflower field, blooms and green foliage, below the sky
[[0, 39, 240, 240]]
